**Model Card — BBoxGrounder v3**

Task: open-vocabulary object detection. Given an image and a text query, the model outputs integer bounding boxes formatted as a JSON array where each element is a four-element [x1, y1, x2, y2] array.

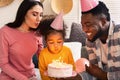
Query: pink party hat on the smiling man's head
[[81, 0, 99, 12]]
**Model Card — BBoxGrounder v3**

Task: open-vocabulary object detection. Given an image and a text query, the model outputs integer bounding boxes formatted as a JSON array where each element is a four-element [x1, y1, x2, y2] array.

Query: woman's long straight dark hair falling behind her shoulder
[[6, 0, 43, 28]]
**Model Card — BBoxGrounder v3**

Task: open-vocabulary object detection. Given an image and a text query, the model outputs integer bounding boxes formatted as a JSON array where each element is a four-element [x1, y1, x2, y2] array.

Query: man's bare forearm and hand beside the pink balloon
[[85, 64, 108, 80]]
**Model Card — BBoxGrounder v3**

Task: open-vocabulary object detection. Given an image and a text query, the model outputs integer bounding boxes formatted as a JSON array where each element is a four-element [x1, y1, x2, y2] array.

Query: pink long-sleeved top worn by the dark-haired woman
[[0, 26, 43, 80]]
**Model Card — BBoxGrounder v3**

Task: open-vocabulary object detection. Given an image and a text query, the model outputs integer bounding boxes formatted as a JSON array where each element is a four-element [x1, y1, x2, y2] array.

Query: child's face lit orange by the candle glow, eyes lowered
[[46, 33, 64, 54]]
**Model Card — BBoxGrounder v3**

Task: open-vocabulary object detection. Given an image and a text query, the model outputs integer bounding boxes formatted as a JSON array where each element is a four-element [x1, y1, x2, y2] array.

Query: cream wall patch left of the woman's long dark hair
[[0, 0, 22, 27]]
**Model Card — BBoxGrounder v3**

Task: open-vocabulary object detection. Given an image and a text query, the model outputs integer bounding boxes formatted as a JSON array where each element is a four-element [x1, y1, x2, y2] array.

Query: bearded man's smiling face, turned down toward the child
[[81, 13, 102, 42]]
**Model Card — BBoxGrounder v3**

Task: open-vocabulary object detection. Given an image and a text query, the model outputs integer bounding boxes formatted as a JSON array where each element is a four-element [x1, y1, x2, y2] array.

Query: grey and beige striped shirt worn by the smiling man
[[86, 22, 120, 80]]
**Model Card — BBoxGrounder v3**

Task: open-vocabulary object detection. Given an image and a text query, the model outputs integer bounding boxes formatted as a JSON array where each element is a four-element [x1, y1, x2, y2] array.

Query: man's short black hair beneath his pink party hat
[[82, 1, 110, 21]]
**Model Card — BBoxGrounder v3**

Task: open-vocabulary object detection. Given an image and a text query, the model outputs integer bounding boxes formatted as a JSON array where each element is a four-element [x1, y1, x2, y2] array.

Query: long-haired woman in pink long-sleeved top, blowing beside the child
[[0, 0, 43, 80]]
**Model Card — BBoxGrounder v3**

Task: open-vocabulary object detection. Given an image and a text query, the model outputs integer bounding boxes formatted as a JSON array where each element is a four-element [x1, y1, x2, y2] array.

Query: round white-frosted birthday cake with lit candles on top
[[48, 60, 73, 78]]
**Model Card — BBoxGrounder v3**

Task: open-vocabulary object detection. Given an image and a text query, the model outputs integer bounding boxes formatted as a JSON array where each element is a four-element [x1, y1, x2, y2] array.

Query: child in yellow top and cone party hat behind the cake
[[38, 13, 75, 80]]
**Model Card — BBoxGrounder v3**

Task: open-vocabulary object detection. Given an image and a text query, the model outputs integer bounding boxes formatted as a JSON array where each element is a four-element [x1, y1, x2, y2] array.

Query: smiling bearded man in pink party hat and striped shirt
[[81, 0, 120, 80]]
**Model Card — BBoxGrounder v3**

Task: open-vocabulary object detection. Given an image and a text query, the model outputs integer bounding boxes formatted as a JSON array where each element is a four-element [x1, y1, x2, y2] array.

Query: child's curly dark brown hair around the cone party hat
[[38, 15, 67, 40]]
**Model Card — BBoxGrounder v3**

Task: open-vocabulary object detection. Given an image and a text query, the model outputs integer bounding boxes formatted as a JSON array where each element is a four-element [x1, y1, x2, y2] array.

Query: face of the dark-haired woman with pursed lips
[[24, 5, 43, 29]]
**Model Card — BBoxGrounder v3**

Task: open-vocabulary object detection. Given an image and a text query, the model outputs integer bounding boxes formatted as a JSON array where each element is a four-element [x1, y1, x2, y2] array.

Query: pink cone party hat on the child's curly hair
[[50, 11, 63, 30]]
